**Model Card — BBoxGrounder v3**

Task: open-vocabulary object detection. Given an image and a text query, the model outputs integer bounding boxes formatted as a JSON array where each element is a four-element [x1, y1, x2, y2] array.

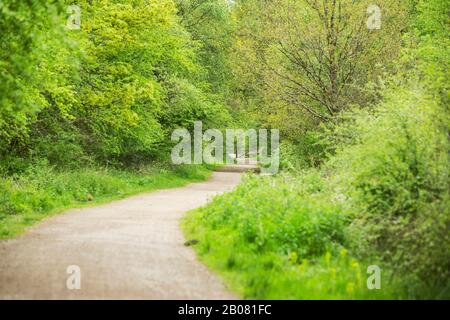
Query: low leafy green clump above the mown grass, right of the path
[[198, 172, 345, 258]]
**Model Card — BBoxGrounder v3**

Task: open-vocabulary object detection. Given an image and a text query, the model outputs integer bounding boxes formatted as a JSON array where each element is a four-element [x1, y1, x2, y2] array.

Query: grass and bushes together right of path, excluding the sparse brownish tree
[[184, 0, 450, 299]]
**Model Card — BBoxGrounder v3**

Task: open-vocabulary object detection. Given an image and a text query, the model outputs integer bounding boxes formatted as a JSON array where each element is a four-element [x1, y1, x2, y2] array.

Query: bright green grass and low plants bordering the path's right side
[[182, 175, 400, 299]]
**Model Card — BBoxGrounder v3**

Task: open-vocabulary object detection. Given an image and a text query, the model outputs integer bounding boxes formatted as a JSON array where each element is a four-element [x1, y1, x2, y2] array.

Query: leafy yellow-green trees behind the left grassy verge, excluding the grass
[[0, 0, 236, 172]]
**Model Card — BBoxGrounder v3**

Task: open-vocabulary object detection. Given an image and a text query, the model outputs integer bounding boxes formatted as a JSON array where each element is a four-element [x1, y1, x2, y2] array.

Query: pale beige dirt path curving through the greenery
[[0, 172, 240, 299]]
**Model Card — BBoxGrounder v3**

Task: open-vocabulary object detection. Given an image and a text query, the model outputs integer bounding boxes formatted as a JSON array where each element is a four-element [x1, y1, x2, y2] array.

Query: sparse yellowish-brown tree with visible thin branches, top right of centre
[[230, 0, 405, 121]]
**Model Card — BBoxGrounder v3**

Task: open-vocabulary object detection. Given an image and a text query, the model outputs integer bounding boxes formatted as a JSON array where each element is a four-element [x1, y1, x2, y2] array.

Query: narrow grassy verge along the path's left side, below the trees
[[0, 165, 210, 239]]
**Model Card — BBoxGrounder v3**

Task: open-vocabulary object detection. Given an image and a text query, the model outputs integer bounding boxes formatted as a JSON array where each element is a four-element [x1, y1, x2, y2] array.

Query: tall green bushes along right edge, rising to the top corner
[[325, 0, 450, 298]]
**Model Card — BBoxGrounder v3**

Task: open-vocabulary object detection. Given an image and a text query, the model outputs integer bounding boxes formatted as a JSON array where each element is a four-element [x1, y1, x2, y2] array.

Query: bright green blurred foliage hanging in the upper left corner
[[0, 0, 76, 156]]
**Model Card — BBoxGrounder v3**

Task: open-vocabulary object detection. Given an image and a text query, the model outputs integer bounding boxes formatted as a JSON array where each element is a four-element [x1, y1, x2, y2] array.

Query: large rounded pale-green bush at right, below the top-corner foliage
[[327, 82, 450, 295]]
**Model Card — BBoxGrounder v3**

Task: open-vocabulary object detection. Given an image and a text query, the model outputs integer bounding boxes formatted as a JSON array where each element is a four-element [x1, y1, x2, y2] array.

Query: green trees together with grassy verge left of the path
[[0, 0, 230, 237]]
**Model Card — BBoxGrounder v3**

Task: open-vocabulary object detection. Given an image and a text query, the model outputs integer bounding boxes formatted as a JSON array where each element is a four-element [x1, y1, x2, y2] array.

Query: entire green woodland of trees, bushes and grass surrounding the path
[[0, 0, 450, 299]]
